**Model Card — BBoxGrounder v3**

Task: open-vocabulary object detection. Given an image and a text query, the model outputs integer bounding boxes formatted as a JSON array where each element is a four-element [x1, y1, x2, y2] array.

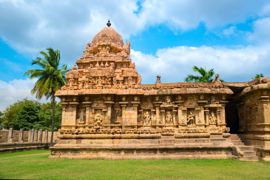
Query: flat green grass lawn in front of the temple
[[0, 150, 270, 179]]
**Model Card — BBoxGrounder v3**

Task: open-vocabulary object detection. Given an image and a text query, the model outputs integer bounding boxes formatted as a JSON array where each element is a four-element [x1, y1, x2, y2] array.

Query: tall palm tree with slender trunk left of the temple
[[25, 48, 68, 145]]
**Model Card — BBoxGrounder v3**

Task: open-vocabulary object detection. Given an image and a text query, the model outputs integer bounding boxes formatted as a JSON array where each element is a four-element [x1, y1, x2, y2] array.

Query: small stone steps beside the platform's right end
[[231, 134, 258, 161]]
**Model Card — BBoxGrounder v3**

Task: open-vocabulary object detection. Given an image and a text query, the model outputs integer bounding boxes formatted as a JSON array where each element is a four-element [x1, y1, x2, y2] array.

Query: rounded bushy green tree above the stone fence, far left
[[2, 99, 40, 130]]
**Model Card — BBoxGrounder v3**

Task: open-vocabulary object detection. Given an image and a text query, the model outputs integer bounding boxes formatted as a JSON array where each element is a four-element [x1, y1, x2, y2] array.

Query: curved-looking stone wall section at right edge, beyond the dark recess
[[238, 81, 270, 160]]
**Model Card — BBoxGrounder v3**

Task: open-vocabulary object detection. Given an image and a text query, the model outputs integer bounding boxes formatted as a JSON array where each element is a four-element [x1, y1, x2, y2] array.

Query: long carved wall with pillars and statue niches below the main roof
[[60, 95, 226, 135]]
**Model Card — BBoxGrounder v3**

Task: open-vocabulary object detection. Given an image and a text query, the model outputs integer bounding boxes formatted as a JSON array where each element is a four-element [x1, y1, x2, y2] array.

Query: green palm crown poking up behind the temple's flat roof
[[185, 66, 215, 82]]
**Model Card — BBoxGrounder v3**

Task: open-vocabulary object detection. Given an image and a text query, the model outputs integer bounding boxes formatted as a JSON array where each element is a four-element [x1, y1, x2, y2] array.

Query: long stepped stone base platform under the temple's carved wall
[[51, 134, 238, 159]]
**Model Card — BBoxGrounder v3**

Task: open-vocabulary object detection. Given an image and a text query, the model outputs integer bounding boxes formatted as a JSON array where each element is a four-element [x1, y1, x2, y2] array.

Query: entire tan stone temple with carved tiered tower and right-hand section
[[51, 23, 270, 160]]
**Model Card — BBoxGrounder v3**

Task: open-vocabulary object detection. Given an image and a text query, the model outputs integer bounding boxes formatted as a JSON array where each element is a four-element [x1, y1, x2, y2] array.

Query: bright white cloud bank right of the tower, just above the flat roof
[[132, 46, 270, 83]]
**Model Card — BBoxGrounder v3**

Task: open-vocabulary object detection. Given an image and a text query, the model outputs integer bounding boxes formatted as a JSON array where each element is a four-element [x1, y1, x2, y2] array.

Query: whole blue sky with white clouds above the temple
[[0, 0, 270, 110]]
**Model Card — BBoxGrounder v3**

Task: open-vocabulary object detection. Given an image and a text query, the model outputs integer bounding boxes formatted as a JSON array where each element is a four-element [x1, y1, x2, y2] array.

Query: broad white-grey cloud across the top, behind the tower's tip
[[0, 0, 268, 64]]
